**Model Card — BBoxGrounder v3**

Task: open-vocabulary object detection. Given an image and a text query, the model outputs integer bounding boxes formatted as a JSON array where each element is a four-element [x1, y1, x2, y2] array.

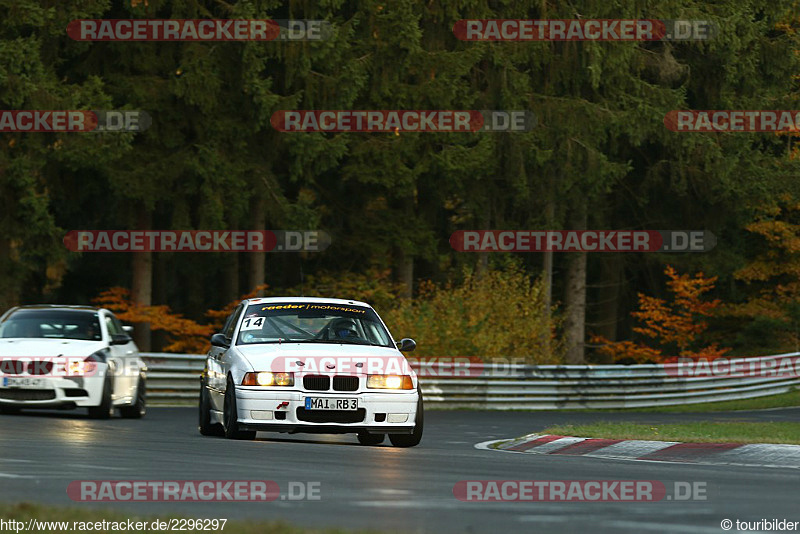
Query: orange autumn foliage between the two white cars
[[93, 284, 268, 354]]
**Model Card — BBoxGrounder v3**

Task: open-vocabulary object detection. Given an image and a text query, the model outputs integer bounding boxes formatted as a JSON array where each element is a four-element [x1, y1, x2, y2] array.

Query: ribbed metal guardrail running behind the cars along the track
[[142, 352, 800, 410]]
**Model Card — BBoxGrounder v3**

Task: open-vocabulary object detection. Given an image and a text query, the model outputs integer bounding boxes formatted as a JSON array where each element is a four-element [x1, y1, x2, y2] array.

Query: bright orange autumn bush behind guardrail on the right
[[591, 265, 730, 363]]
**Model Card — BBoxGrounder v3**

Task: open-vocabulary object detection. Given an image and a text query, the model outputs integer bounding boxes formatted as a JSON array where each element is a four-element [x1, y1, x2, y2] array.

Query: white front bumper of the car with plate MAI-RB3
[[236, 387, 419, 434]]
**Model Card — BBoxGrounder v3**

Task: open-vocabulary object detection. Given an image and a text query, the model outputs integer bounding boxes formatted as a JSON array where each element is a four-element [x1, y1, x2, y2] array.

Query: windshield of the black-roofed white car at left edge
[[0, 310, 102, 341]]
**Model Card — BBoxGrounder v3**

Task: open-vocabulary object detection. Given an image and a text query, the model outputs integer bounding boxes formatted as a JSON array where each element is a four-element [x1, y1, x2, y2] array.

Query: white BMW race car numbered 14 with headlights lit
[[199, 297, 423, 447]]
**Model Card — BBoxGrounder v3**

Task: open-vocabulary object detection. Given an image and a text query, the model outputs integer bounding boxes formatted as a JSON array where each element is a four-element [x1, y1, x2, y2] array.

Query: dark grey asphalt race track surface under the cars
[[0, 408, 800, 533]]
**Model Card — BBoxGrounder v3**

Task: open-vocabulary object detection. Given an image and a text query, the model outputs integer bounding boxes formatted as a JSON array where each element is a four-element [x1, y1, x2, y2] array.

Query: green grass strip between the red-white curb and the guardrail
[[541, 421, 800, 445]]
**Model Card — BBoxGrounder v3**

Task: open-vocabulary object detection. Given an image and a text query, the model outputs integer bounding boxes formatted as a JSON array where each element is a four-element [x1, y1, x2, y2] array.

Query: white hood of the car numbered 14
[[236, 343, 414, 374]]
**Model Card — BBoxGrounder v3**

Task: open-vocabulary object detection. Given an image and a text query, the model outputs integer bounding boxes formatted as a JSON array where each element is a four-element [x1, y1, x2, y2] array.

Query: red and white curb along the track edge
[[475, 434, 800, 469]]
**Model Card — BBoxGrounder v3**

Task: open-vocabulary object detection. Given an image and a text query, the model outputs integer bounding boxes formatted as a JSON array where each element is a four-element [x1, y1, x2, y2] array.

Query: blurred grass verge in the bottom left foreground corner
[[0, 503, 376, 534]]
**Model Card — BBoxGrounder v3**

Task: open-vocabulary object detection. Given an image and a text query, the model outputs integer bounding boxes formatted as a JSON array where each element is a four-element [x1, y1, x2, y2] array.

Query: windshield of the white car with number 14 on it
[[237, 302, 392, 347]]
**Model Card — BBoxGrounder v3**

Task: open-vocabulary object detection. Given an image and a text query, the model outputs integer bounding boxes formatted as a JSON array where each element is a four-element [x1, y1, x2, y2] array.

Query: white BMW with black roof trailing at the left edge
[[0, 305, 147, 419]]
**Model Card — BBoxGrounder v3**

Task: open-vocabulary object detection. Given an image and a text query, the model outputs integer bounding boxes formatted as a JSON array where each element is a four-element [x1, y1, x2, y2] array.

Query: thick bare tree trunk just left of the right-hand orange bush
[[564, 206, 586, 365]]
